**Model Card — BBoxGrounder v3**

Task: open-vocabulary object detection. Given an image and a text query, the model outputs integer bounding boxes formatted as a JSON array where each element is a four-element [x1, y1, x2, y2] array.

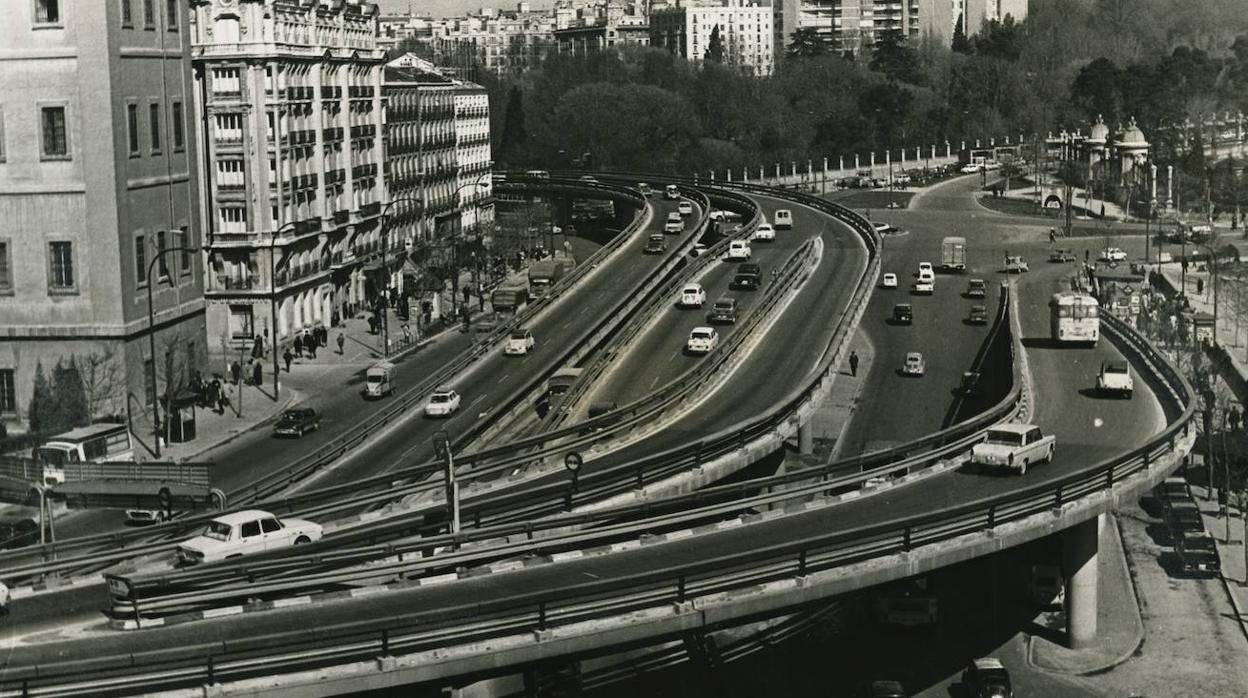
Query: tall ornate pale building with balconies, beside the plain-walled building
[[191, 0, 384, 369]]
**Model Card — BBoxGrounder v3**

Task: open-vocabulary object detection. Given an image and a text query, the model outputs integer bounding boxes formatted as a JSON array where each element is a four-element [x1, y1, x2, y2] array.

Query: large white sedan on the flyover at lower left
[[177, 509, 323, 564]]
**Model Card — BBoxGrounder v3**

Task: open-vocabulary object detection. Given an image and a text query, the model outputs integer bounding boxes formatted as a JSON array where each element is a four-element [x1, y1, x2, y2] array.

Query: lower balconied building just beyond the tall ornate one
[[384, 54, 494, 257]]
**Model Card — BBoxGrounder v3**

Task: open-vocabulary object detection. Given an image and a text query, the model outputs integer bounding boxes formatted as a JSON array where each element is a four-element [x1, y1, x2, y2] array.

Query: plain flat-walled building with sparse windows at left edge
[[0, 0, 206, 437]]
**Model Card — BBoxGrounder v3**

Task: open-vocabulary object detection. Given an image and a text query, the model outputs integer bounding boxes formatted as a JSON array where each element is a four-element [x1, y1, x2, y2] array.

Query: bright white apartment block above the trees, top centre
[[650, 0, 775, 75]]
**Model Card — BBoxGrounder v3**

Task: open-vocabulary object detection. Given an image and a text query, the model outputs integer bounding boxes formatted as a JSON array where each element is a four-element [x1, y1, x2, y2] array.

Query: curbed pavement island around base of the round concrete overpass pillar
[[1027, 514, 1144, 676]]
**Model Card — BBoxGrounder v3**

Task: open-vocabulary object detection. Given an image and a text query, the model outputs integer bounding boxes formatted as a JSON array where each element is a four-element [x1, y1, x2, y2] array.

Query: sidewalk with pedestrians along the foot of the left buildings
[[146, 262, 536, 461]]
